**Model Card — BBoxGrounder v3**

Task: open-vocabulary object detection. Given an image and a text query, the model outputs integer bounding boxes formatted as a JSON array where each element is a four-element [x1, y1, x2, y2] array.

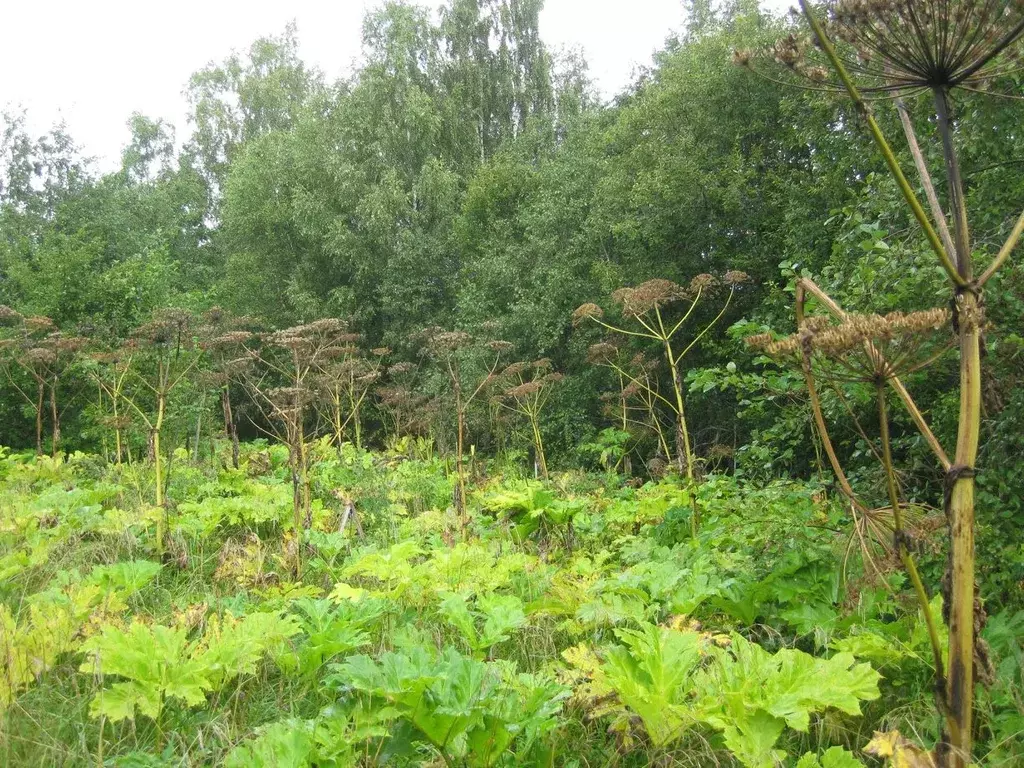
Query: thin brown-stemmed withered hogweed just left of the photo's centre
[[421, 328, 512, 536]]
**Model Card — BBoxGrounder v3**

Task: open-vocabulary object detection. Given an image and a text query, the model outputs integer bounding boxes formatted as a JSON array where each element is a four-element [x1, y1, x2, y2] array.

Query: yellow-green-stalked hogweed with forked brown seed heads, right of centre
[[572, 270, 749, 534]]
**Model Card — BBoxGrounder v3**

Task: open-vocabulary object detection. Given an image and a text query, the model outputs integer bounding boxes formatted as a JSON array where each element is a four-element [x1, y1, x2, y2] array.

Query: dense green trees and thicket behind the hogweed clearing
[[0, 0, 1024, 593]]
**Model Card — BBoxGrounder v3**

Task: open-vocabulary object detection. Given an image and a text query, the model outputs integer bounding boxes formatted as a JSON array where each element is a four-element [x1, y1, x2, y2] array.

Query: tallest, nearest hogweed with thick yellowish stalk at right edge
[[735, 0, 1024, 768]]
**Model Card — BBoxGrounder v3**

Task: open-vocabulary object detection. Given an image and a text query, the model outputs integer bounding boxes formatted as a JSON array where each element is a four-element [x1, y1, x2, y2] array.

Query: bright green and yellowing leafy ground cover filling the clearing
[[0, 443, 1024, 768]]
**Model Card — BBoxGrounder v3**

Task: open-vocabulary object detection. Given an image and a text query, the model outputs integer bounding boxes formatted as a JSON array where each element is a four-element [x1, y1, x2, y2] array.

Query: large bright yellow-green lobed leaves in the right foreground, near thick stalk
[[570, 624, 880, 768]]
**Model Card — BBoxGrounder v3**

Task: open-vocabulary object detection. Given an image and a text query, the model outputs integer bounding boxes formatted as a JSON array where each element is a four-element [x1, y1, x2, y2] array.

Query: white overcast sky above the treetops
[[0, 0, 696, 171]]
